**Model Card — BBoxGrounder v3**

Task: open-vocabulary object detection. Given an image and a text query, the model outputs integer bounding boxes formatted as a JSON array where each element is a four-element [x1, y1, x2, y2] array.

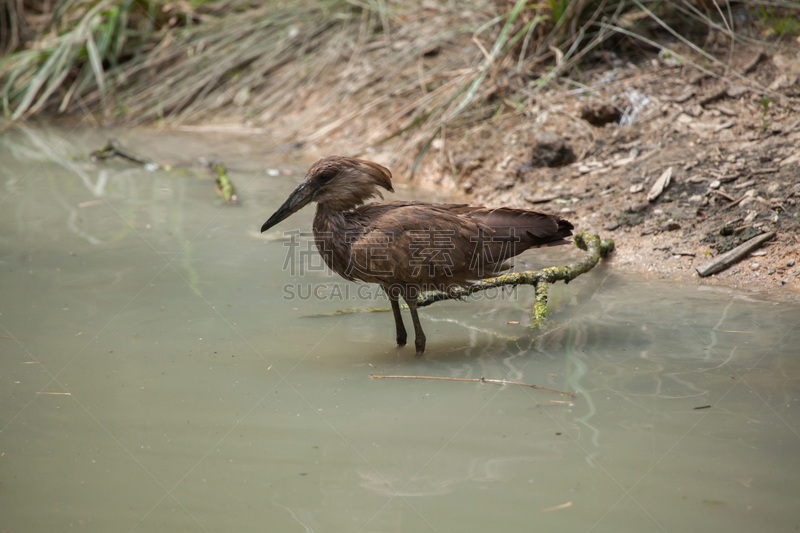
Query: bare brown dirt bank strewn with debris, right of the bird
[[274, 45, 800, 297]]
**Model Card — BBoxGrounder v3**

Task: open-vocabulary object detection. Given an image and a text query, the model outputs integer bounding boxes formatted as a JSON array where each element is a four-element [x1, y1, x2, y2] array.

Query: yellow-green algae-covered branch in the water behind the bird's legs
[[303, 233, 614, 328]]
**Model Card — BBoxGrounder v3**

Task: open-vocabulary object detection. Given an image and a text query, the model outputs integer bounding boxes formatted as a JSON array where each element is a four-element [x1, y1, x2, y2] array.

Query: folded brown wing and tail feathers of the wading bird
[[350, 202, 572, 285]]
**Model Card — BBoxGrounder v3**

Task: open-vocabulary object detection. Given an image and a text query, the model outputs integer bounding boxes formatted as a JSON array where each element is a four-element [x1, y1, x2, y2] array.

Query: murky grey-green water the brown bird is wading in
[[0, 128, 800, 533]]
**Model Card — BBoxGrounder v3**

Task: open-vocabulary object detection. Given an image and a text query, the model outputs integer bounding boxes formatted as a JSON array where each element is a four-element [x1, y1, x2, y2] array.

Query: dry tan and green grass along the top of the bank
[[0, 0, 800, 166]]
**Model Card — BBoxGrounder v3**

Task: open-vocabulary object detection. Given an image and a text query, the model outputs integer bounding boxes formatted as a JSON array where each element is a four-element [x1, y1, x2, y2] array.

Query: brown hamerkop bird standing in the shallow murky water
[[261, 156, 572, 354]]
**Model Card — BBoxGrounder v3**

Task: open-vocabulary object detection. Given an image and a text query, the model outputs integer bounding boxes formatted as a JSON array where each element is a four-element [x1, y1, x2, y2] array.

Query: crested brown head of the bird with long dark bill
[[261, 156, 394, 233]]
